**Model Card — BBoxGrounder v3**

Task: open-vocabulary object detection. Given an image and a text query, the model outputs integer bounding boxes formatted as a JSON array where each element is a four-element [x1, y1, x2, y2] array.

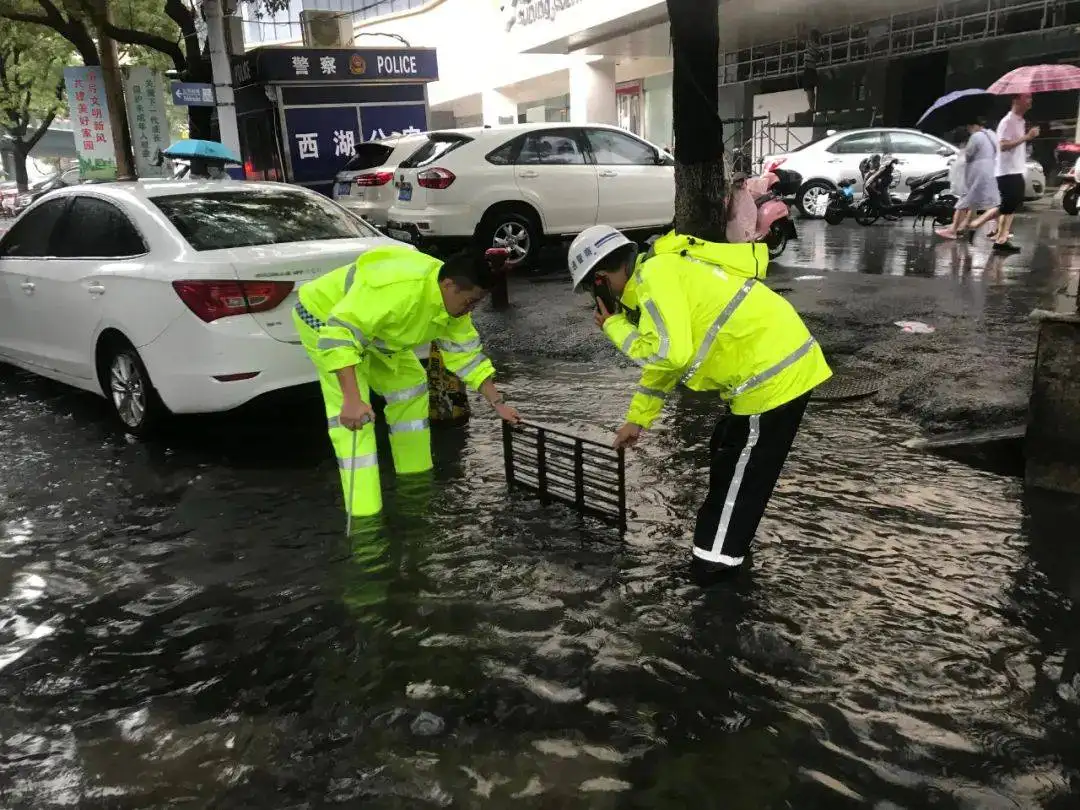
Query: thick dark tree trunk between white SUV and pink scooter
[[667, 0, 727, 242]]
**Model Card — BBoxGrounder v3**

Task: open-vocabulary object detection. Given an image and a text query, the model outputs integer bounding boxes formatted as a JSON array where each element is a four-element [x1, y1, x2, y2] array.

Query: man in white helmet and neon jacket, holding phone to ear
[[570, 226, 832, 573]]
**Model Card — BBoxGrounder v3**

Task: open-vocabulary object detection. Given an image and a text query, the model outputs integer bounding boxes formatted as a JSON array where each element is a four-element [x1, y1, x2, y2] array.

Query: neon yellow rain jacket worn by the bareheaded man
[[299, 245, 495, 389]]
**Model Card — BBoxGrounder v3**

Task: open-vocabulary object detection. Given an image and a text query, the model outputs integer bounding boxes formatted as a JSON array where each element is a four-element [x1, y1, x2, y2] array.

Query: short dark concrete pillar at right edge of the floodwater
[[1025, 311, 1080, 495]]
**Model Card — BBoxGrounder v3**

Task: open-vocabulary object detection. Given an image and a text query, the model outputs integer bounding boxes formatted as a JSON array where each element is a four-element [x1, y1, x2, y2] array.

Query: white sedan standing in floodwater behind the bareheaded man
[[0, 181, 403, 435]]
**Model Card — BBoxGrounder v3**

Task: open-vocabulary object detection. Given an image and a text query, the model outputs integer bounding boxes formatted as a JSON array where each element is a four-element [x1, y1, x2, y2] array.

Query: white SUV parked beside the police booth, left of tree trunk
[[387, 123, 675, 265]]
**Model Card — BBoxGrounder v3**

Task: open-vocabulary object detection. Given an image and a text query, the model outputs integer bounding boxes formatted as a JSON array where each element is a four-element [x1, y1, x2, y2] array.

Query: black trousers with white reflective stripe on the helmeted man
[[693, 393, 810, 566]]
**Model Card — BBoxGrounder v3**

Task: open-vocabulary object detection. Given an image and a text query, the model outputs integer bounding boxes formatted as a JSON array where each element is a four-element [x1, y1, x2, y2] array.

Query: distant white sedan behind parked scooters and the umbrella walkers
[[762, 129, 1047, 216]]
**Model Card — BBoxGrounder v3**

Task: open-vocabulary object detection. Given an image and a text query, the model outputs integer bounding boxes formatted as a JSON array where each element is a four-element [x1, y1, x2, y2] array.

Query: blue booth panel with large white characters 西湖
[[285, 106, 363, 184]]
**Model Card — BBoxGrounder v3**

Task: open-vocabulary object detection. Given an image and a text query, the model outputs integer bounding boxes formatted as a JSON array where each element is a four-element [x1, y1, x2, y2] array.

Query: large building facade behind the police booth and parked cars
[[251, 0, 1080, 158]]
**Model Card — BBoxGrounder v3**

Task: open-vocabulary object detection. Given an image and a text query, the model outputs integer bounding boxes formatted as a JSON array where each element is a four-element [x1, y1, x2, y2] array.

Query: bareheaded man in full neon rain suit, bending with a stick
[[293, 245, 519, 517]]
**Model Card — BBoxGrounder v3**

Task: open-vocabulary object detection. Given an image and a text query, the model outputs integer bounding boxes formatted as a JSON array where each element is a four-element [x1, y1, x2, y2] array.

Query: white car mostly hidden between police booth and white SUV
[[334, 134, 428, 228]]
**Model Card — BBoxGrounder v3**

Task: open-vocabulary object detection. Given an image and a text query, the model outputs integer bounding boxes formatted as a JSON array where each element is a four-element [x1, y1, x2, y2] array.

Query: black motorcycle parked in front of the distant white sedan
[[854, 154, 957, 228]]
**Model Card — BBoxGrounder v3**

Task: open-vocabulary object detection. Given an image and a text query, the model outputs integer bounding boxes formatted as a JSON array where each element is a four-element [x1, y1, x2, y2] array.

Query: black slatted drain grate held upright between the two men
[[502, 422, 626, 532]]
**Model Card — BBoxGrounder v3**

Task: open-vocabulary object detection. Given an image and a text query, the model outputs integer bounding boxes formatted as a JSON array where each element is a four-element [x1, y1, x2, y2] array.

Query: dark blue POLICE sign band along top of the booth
[[247, 48, 438, 85]]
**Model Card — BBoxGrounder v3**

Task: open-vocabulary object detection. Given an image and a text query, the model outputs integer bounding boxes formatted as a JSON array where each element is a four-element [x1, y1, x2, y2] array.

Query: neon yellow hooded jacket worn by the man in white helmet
[[604, 244, 832, 428]]
